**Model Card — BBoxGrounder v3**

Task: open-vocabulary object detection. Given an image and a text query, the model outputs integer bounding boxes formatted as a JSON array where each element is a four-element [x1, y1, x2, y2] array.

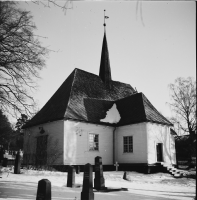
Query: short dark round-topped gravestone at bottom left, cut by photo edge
[[36, 179, 51, 200]]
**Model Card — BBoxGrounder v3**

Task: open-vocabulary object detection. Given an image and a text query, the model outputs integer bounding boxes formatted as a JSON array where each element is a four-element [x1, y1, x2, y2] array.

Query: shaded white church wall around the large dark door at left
[[24, 120, 64, 165]]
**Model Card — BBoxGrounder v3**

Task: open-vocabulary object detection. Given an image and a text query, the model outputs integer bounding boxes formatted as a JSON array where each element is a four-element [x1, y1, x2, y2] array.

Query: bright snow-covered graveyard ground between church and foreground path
[[0, 168, 196, 200]]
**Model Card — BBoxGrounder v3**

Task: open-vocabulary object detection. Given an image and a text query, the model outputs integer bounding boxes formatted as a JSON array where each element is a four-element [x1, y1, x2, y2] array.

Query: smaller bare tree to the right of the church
[[169, 77, 196, 161]]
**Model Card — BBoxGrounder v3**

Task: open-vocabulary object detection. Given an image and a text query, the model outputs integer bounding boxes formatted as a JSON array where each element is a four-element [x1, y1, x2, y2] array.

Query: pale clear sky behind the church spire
[[19, 1, 196, 122]]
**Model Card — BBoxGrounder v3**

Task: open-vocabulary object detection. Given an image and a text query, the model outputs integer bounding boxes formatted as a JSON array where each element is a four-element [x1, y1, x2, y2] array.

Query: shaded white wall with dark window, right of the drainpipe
[[115, 123, 147, 163]]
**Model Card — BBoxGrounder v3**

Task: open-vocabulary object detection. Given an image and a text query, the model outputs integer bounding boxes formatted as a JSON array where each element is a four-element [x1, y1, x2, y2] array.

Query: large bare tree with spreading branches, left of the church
[[0, 1, 48, 115]]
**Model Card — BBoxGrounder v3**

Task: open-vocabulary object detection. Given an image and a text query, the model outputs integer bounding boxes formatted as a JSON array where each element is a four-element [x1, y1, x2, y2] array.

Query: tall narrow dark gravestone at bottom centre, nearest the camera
[[81, 163, 94, 200]]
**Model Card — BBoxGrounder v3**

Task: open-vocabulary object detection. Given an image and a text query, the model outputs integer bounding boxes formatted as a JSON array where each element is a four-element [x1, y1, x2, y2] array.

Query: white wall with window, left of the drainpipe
[[64, 120, 113, 165]]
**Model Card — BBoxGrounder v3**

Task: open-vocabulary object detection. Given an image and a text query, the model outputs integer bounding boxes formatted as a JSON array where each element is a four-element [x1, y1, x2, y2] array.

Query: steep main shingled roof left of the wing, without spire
[[23, 68, 135, 128]]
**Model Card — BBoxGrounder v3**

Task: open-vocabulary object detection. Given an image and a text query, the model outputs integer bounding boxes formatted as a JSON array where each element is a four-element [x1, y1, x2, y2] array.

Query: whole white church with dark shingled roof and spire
[[23, 27, 176, 173]]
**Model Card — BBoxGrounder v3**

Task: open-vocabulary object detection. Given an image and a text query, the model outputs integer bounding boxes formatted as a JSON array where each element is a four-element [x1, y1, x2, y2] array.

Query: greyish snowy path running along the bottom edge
[[0, 181, 193, 200]]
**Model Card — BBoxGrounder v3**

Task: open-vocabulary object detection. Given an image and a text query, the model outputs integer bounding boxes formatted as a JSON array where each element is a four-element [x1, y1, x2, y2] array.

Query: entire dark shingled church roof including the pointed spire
[[23, 34, 172, 128]]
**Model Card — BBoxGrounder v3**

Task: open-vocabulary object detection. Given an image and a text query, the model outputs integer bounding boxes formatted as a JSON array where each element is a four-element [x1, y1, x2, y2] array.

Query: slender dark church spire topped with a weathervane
[[99, 10, 111, 86]]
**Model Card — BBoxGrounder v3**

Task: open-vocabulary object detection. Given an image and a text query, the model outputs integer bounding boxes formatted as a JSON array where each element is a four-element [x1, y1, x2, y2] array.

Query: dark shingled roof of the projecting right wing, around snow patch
[[79, 93, 172, 126]]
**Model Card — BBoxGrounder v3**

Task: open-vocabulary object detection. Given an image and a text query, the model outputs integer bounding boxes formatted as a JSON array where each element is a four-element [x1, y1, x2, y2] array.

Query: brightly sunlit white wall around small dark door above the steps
[[147, 123, 176, 164]]
